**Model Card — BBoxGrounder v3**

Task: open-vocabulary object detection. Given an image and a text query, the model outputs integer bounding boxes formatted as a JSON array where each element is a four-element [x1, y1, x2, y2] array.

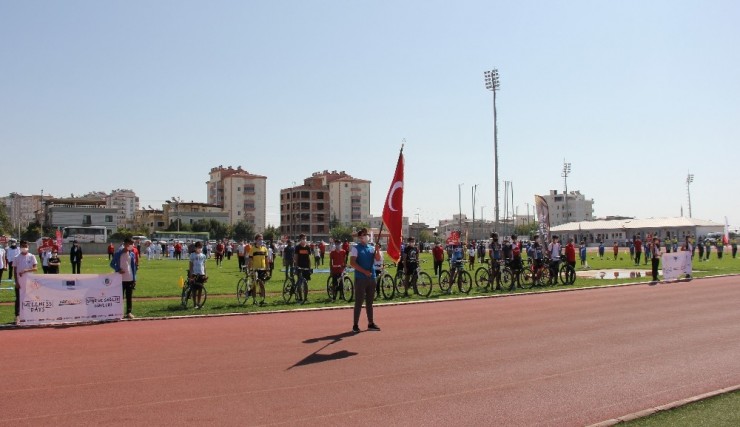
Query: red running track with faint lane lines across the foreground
[[0, 277, 740, 426]]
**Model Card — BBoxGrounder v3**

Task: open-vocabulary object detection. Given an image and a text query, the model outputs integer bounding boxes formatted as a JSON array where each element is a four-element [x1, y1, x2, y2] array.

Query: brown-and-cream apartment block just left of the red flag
[[280, 170, 370, 244]]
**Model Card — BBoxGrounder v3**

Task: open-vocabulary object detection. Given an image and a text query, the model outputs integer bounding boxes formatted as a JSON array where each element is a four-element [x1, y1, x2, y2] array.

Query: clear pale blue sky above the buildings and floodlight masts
[[0, 0, 740, 229]]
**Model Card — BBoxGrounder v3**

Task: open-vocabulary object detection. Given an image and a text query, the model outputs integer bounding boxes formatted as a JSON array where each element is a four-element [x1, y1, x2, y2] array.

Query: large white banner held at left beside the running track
[[19, 273, 123, 325]]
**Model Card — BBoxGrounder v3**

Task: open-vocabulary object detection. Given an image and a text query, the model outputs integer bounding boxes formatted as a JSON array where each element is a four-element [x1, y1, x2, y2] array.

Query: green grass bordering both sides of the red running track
[[0, 250, 740, 426]]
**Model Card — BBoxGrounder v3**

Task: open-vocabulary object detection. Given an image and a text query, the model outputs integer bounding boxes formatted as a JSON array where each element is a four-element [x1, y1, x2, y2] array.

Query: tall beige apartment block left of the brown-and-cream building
[[206, 166, 267, 233]]
